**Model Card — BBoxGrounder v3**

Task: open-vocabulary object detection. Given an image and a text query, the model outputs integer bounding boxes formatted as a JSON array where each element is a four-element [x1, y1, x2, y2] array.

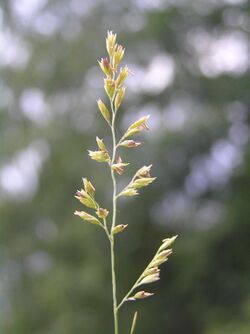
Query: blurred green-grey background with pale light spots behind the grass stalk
[[0, 0, 250, 334]]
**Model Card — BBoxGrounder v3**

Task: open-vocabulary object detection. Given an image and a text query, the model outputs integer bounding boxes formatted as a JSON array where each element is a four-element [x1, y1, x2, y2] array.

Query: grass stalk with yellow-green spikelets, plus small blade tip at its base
[[75, 31, 177, 334]]
